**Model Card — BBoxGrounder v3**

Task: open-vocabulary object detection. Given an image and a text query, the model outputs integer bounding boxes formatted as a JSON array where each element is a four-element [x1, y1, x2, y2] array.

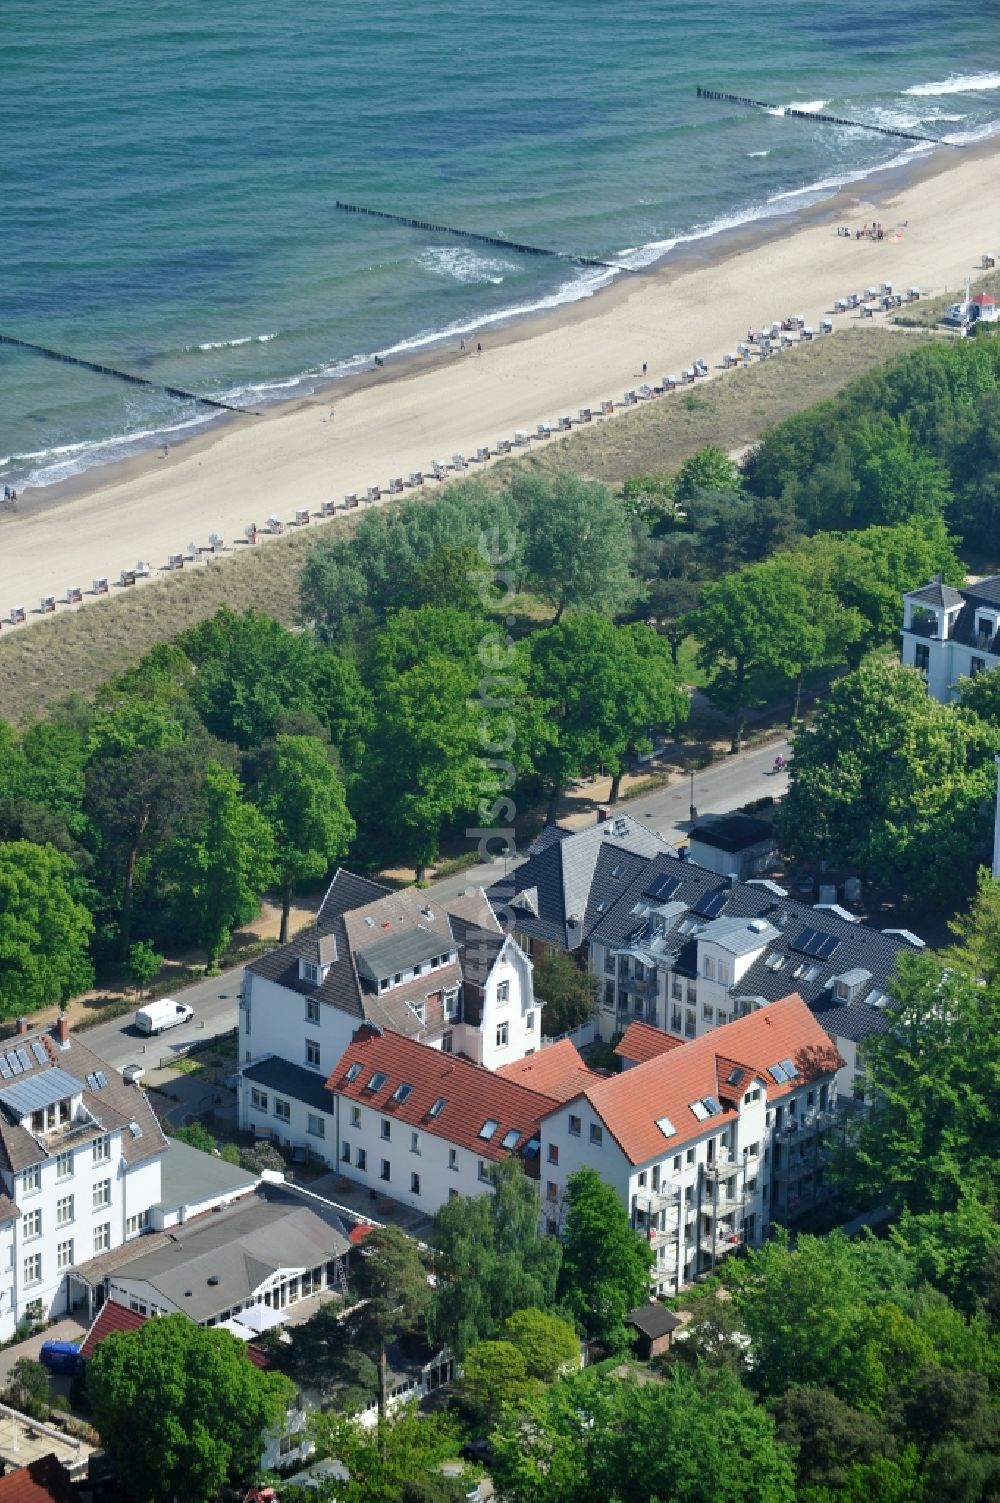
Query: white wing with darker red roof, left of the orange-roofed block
[[326, 1025, 555, 1216]]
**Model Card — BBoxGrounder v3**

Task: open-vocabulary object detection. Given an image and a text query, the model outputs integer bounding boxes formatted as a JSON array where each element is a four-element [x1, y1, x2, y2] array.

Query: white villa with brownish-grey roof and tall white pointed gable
[[239, 870, 541, 1160]]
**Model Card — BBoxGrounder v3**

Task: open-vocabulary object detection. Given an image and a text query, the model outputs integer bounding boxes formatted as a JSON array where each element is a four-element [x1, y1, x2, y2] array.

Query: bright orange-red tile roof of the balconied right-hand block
[[582, 995, 844, 1163]]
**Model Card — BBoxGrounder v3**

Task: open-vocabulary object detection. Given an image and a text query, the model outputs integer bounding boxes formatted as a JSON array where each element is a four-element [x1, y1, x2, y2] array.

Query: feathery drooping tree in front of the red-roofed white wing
[[427, 1159, 562, 1360]]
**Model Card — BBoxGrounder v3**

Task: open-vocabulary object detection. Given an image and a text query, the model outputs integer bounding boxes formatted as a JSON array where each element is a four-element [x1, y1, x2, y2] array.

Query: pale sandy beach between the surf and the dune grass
[[0, 141, 1000, 637]]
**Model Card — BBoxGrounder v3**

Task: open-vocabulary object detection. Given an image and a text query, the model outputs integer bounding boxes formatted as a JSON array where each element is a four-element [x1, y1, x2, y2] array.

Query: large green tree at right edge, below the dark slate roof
[[847, 954, 1000, 1235]]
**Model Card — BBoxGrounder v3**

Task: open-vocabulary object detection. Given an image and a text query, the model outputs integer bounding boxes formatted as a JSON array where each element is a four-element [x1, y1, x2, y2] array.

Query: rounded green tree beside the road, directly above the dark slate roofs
[[529, 610, 687, 822]]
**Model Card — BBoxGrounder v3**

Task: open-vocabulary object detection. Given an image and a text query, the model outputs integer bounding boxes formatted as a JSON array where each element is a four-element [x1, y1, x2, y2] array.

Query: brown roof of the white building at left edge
[[0, 1028, 167, 1178]]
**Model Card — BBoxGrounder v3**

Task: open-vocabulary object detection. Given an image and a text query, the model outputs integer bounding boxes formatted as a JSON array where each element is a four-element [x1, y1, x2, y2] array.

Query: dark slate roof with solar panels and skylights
[[589, 855, 913, 1042]]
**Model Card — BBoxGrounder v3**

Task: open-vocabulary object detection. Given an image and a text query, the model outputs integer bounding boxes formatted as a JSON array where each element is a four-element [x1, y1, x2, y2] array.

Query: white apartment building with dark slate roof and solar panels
[[490, 825, 923, 1094]]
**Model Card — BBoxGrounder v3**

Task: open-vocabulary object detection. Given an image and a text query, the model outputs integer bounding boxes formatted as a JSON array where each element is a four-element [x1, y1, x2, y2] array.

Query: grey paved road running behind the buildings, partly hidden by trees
[[84, 741, 789, 1069]]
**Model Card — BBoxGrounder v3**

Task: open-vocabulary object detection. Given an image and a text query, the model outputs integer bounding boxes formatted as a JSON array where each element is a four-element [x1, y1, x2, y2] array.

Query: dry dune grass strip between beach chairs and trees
[[0, 325, 934, 723]]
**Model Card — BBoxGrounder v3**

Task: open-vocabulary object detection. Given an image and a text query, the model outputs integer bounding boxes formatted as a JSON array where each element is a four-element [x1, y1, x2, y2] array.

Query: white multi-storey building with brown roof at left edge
[[0, 1018, 167, 1339]]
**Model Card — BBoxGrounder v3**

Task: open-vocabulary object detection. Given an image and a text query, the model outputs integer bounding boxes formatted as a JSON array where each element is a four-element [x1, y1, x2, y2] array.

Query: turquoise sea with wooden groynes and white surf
[[0, 0, 1000, 484]]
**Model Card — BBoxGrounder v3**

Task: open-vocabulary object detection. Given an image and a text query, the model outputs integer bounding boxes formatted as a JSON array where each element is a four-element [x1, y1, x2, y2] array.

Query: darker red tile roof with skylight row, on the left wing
[[326, 1027, 556, 1160]]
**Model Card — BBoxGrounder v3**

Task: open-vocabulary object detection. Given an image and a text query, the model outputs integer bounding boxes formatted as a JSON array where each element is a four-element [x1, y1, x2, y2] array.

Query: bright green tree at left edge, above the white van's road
[[0, 840, 93, 1018]]
